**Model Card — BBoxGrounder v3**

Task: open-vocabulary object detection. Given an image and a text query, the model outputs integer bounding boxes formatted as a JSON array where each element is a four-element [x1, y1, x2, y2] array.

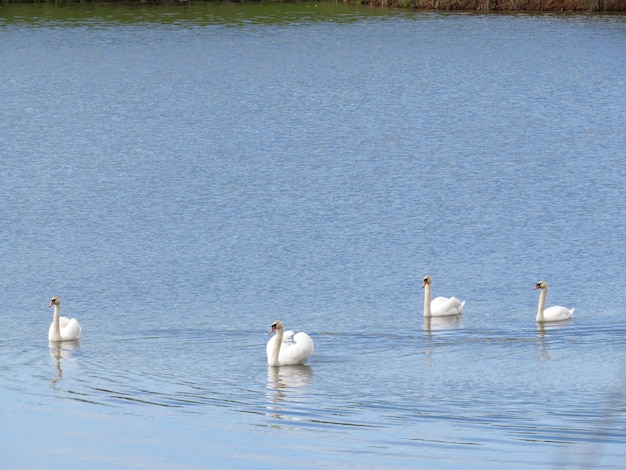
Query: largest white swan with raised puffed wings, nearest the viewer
[[266, 320, 313, 366]]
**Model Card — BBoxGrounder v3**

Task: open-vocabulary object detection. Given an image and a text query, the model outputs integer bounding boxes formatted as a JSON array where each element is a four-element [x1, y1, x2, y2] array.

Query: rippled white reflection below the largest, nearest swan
[[266, 365, 313, 419]]
